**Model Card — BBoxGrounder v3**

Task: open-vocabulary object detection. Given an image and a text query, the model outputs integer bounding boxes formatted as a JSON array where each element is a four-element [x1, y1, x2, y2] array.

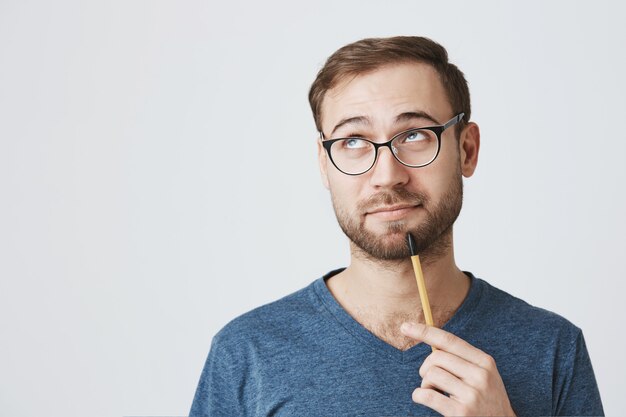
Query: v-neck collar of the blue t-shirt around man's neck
[[313, 268, 484, 363]]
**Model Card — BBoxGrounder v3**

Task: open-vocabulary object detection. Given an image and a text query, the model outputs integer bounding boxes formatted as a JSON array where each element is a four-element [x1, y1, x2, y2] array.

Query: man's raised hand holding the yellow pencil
[[400, 323, 515, 416]]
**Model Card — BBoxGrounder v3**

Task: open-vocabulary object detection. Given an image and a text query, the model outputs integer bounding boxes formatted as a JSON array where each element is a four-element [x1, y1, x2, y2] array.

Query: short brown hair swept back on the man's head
[[309, 36, 471, 137]]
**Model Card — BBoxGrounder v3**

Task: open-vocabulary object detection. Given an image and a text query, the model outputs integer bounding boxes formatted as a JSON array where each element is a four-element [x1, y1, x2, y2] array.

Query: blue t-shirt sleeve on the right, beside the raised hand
[[553, 329, 604, 416]]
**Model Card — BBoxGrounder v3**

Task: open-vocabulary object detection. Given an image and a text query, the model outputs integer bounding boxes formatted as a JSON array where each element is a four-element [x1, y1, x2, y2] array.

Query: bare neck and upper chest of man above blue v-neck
[[328, 231, 469, 330]]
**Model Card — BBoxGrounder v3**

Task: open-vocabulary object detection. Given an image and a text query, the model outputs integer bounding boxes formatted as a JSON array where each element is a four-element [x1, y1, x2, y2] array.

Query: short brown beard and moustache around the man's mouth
[[331, 169, 463, 263]]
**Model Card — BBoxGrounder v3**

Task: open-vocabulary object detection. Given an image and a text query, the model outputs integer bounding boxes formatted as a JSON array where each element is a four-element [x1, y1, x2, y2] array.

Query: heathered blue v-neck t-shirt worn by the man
[[190, 271, 604, 417]]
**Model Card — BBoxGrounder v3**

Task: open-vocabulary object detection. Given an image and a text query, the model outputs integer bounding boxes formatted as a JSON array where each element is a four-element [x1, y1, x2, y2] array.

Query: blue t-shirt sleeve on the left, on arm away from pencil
[[189, 336, 246, 417]]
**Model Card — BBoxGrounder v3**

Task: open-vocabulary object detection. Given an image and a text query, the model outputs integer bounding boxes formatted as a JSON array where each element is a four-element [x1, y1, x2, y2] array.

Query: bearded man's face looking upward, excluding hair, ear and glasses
[[319, 63, 473, 260]]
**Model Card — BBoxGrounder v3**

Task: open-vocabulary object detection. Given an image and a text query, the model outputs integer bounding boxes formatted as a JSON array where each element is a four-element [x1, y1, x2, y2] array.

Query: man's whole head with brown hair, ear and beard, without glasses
[[309, 37, 479, 260]]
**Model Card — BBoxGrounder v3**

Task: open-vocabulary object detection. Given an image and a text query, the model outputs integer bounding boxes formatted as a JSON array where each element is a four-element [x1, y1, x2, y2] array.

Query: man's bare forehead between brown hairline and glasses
[[321, 63, 452, 133]]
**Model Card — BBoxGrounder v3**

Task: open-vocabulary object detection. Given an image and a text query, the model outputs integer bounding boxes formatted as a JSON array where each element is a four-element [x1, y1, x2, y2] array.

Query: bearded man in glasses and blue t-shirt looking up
[[191, 37, 603, 416]]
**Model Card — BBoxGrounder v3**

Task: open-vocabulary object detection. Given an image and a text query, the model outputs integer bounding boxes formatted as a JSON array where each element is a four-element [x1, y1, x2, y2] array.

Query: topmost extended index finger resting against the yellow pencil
[[400, 323, 493, 368]]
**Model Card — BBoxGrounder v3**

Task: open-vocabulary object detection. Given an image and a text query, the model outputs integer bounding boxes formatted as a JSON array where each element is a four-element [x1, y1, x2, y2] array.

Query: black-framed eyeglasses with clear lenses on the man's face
[[320, 113, 465, 175]]
